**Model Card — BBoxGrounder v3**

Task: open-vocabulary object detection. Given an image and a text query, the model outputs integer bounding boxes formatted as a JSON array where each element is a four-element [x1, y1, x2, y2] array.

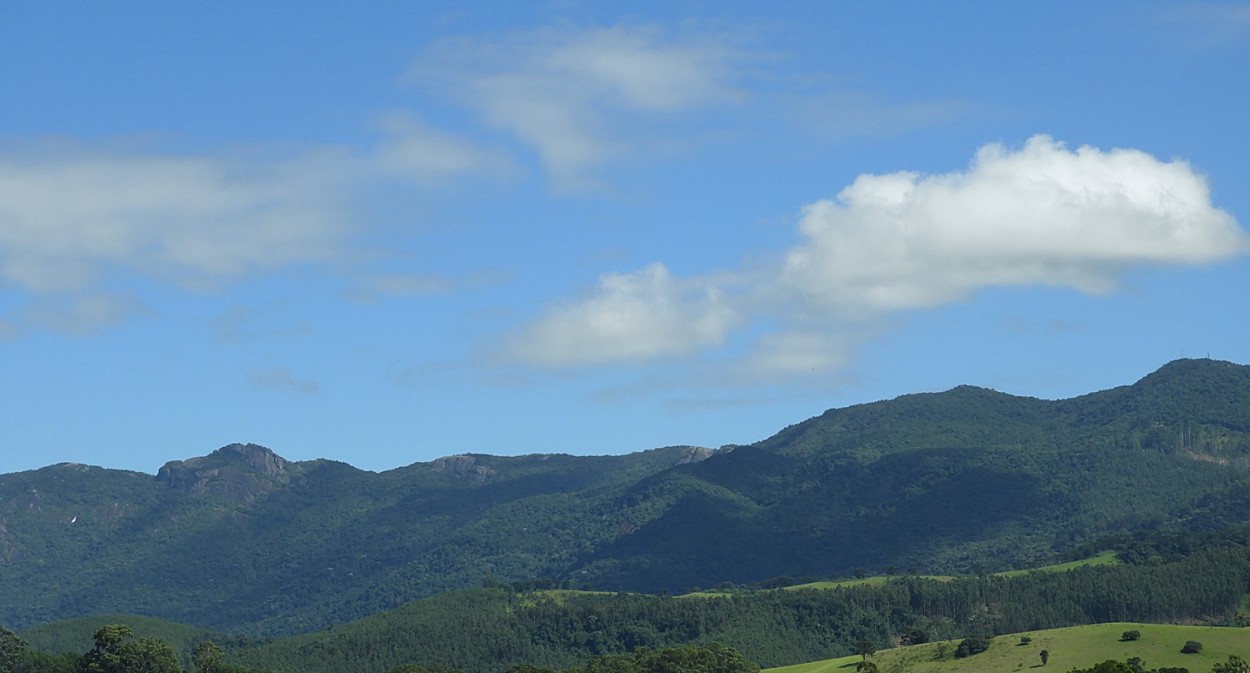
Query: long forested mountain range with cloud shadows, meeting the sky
[[0, 360, 1250, 633]]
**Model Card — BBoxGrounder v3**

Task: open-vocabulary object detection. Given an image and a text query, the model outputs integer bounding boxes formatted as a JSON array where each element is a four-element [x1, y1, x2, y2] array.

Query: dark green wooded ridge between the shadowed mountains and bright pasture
[[202, 544, 1250, 673]]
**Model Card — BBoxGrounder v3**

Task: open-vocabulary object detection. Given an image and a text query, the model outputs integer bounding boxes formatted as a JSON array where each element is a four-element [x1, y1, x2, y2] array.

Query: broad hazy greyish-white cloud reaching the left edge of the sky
[[0, 124, 506, 335]]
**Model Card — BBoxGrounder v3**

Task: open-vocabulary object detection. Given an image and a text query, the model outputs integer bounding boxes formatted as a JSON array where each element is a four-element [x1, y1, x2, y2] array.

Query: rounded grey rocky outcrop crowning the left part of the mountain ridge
[[156, 444, 291, 503]]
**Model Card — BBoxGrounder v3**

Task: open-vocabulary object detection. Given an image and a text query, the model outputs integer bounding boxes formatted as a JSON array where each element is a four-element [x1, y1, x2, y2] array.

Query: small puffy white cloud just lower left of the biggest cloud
[[510, 264, 738, 367]]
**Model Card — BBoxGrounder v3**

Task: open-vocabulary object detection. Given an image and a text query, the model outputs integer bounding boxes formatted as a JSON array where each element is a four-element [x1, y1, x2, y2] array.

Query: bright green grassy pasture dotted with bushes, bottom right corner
[[766, 623, 1250, 673]]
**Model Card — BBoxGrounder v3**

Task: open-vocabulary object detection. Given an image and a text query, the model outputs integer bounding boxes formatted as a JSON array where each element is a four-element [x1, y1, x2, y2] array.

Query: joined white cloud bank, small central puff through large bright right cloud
[[510, 135, 1250, 382]]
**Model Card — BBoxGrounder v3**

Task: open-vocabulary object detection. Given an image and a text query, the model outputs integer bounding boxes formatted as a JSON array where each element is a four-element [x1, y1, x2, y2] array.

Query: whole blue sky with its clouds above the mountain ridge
[[0, 1, 1250, 473]]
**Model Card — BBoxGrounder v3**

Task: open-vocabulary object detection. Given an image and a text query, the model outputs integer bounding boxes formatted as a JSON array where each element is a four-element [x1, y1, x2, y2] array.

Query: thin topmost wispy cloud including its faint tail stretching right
[[411, 24, 966, 189]]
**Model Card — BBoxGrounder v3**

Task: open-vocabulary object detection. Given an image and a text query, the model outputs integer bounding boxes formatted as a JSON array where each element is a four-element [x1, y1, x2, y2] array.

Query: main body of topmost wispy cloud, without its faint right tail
[[414, 25, 739, 186]]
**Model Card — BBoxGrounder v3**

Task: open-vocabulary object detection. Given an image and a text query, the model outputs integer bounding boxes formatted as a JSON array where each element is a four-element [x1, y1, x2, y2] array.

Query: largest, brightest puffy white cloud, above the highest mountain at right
[[779, 135, 1248, 315]]
